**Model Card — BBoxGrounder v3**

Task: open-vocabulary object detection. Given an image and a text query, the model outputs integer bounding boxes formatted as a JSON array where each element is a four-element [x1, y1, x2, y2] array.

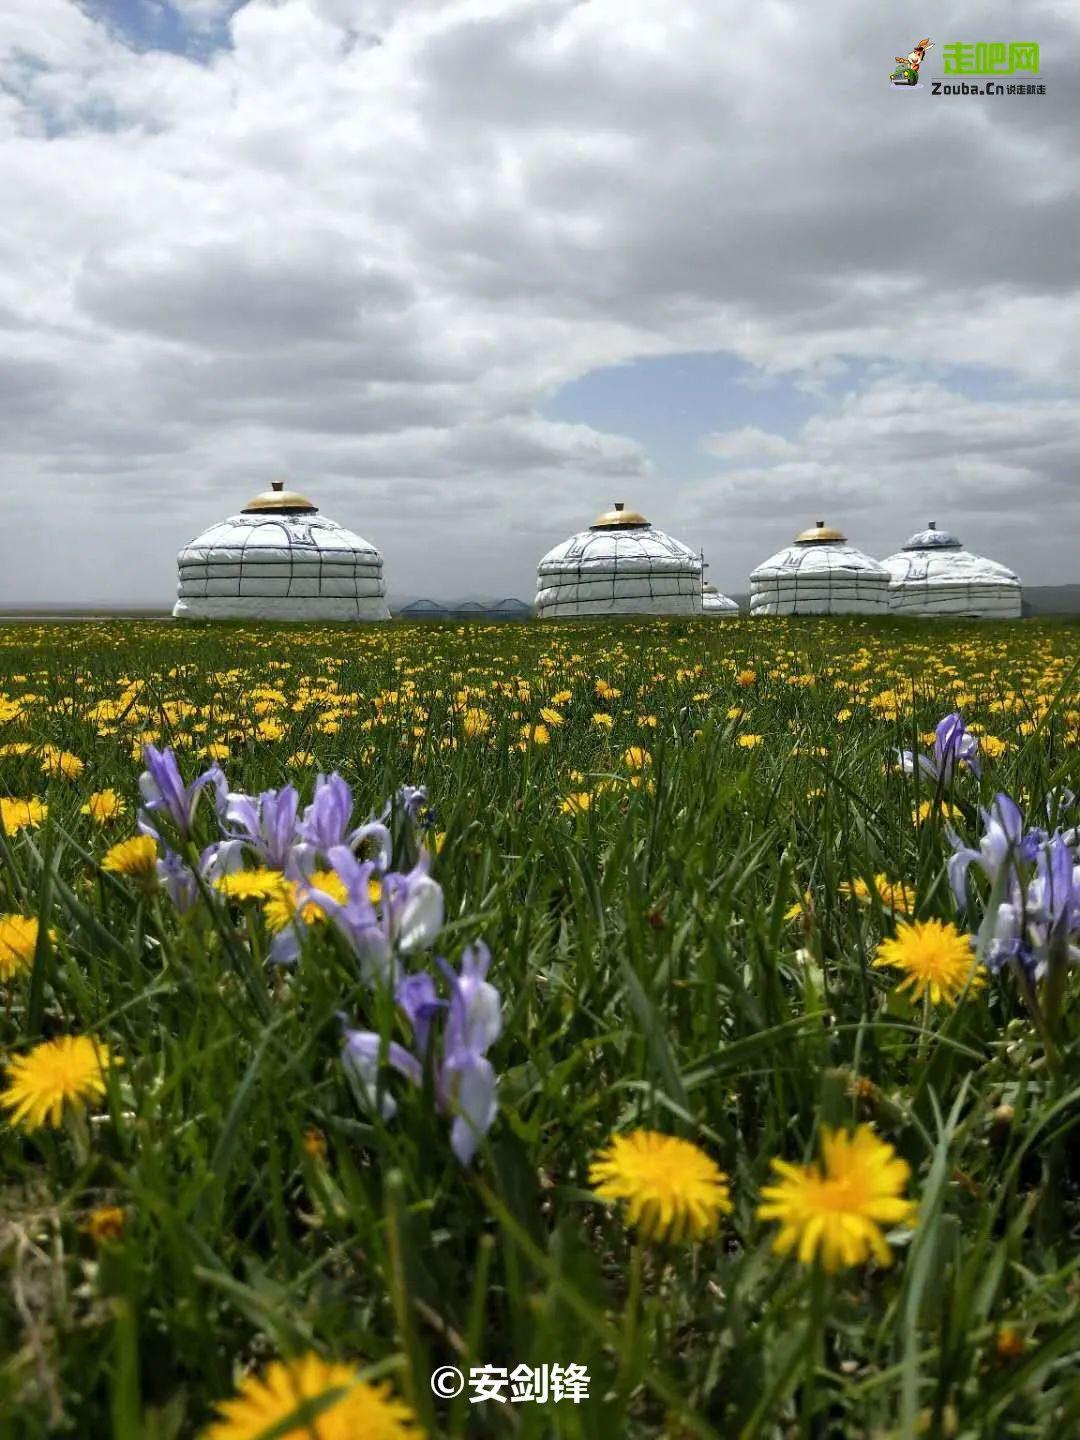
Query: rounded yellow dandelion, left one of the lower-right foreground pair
[[589, 1130, 732, 1241]]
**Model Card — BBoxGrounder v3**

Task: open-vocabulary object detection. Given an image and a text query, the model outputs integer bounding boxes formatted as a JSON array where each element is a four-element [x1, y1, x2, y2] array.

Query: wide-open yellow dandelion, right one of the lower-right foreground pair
[[757, 1125, 916, 1273]]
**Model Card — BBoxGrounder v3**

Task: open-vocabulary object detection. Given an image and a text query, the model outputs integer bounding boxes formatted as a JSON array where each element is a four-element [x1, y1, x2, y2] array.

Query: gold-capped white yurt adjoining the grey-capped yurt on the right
[[750, 520, 888, 615]]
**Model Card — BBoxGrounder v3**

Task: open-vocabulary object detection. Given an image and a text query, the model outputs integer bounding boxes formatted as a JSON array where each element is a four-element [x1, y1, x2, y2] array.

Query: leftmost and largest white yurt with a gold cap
[[173, 481, 390, 621]]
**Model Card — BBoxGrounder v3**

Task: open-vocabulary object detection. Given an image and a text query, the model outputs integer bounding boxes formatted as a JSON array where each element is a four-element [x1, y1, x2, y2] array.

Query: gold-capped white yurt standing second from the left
[[536, 501, 701, 619]]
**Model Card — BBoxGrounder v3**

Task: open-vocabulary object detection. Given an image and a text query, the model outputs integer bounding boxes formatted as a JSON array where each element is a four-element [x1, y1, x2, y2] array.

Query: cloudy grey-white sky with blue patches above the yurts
[[0, 0, 1080, 605]]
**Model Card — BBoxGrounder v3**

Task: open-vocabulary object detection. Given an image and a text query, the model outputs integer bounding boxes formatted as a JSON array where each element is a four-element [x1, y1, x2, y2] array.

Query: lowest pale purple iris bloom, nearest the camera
[[343, 945, 503, 1165]]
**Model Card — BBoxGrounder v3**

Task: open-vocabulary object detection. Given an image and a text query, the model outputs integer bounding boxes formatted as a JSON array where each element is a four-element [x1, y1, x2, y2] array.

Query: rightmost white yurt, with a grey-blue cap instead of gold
[[881, 520, 1024, 619]]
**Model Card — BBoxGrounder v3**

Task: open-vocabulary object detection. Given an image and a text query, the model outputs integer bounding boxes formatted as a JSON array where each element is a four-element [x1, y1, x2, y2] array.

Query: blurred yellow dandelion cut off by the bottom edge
[[203, 1355, 423, 1440]]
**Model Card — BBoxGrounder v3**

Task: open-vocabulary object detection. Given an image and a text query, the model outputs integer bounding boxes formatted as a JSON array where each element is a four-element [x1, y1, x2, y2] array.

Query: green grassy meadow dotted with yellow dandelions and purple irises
[[0, 619, 1080, 1440]]
